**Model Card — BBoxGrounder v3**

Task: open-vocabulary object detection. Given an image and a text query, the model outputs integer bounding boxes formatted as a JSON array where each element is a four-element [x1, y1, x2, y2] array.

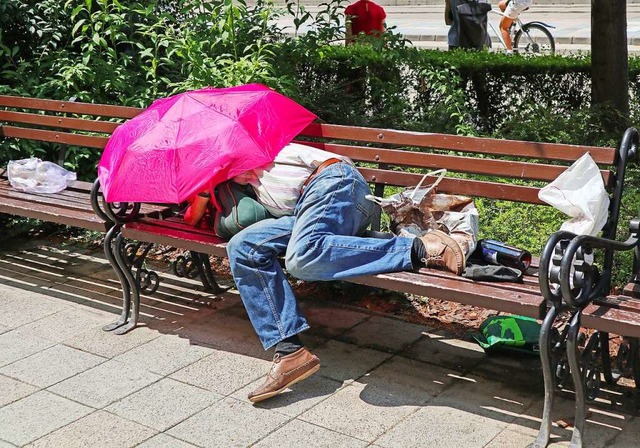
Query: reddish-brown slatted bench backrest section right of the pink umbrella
[[301, 124, 616, 204]]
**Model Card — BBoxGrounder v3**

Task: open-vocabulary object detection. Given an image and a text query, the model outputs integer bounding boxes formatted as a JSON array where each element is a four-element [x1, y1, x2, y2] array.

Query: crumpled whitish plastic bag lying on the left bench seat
[[7, 157, 76, 193]]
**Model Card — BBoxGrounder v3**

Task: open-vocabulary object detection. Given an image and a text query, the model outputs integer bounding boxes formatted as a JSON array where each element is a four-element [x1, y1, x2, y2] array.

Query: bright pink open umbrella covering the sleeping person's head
[[98, 84, 316, 203]]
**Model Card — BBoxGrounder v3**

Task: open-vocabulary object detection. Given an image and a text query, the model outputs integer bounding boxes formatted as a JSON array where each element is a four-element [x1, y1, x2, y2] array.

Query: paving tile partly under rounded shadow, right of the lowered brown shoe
[[298, 357, 451, 440]]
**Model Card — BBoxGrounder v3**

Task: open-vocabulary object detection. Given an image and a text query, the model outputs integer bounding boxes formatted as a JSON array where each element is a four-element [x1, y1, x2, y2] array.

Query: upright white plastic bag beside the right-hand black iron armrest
[[538, 153, 609, 236]]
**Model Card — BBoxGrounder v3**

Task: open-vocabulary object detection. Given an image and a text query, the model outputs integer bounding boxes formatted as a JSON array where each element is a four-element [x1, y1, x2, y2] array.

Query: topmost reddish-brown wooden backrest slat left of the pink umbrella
[[0, 95, 143, 118]]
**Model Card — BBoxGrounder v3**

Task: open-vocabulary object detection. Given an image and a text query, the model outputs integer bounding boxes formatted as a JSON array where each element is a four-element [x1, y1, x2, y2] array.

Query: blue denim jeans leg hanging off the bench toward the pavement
[[227, 216, 309, 350]]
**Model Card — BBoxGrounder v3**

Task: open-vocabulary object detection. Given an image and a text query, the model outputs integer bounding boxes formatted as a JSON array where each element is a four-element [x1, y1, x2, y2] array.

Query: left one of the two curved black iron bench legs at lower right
[[527, 306, 560, 448]]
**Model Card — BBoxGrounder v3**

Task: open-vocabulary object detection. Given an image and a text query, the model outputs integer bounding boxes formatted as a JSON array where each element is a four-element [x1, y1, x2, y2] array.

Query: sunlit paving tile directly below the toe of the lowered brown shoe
[[167, 398, 292, 448]]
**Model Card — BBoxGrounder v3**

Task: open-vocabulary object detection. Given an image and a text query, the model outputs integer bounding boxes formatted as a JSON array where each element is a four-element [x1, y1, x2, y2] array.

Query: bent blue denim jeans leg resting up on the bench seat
[[285, 163, 413, 281]]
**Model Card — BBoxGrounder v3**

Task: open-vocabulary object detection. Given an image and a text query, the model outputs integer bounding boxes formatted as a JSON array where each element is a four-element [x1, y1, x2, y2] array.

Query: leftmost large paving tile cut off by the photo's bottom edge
[[28, 411, 156, 448]]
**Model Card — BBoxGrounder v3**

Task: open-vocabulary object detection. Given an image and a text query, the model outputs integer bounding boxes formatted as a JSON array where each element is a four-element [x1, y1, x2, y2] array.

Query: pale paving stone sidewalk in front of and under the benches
[[0, 241, 640, 448]]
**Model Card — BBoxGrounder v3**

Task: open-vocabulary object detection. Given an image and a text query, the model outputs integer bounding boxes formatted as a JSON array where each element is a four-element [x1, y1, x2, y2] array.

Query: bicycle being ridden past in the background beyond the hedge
[[488, 9, 556, 56]]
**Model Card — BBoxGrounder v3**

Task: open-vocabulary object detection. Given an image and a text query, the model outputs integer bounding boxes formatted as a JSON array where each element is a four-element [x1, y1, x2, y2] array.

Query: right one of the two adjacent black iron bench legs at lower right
[[567, 311, 587, 448]]
